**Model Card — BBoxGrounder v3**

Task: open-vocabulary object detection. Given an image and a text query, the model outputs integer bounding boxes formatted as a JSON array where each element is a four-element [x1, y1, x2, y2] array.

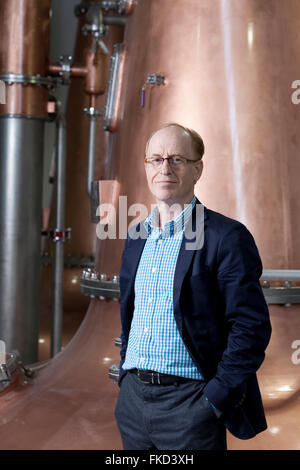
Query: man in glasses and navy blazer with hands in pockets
[[115, 123, 271, 450]]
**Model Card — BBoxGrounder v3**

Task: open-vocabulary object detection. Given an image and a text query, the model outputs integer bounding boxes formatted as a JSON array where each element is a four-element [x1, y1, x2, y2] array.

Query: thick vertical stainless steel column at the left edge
[[0, 116, 45, 364]]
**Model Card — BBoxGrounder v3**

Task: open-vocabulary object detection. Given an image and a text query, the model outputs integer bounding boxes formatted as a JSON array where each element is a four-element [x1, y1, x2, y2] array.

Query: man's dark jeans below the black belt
[[115, 372, 227, 450]]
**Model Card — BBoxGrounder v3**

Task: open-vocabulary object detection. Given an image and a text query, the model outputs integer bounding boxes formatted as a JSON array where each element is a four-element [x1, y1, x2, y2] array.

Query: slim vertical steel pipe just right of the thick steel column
[[51, 114, 66, 356]]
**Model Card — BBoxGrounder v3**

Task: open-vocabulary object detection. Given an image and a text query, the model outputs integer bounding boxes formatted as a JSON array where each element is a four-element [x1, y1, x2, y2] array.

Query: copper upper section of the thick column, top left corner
[[0, 0, 51, 117]]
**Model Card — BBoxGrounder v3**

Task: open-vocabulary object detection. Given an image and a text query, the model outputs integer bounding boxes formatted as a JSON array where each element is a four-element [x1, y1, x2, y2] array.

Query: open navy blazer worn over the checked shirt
[[119, 199, 271, 439]]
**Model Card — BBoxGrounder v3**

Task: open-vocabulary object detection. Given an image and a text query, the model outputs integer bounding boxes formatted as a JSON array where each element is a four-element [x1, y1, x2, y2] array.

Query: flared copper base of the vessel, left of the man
[[0, 301, 122, 450]]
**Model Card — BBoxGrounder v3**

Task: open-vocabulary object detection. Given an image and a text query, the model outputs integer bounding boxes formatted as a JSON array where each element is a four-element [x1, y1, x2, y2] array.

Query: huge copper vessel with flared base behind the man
[[0, 0, 300, 449]]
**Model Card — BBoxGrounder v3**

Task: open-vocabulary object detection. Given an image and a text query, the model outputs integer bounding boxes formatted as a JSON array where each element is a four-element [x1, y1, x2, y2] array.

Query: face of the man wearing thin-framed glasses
[[145, 126, 203, 205]]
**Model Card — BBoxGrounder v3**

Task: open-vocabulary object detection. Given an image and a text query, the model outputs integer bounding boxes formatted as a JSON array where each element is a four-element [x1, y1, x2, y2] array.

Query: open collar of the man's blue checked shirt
[[143, 196, 196, 238]]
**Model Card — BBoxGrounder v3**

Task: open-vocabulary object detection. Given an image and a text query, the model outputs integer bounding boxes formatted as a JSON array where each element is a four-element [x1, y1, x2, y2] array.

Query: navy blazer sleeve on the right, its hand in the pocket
[[203, 222, 271, 411]]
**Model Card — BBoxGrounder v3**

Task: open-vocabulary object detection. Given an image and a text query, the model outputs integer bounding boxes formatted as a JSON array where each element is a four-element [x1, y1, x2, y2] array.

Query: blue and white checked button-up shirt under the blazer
[[122, 196, 202, 379]]
